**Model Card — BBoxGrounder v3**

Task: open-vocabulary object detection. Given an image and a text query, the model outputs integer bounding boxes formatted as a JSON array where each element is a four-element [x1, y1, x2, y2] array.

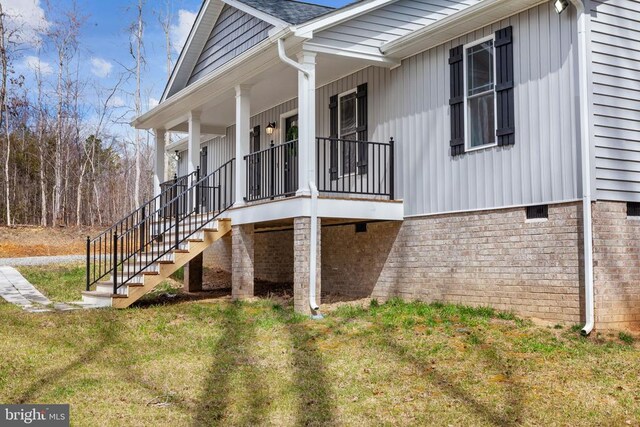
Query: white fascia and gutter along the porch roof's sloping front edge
[[131, 28, 291, 129]]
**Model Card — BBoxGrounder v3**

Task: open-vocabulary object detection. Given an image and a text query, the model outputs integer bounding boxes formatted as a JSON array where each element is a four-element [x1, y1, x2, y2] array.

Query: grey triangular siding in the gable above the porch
[[187, 6, 273, 85]]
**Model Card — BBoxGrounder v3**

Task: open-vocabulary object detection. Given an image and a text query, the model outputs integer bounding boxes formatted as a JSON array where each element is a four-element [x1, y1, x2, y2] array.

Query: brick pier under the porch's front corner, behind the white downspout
[[293, 217, 322, 314]]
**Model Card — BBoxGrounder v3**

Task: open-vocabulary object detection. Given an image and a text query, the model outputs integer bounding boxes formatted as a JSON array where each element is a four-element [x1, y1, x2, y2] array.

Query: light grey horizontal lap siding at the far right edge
[[590, 0, 640, 202]]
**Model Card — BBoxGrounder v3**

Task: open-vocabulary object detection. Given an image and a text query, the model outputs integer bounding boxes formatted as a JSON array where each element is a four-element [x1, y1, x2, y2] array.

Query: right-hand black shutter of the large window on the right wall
[[495, 27, 515, 146]]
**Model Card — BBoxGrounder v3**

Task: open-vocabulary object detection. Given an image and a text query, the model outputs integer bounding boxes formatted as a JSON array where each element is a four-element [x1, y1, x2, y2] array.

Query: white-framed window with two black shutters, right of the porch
[[449, 27, 515, 156]]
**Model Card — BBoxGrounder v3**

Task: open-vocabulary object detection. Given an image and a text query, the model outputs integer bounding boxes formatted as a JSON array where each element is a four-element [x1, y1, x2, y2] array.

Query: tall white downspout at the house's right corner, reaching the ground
[[571, 0, 595, 335]]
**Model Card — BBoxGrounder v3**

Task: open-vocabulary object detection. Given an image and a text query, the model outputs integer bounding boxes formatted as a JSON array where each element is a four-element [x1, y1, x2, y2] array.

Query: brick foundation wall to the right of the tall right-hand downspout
[[593, 201, 640, 330]]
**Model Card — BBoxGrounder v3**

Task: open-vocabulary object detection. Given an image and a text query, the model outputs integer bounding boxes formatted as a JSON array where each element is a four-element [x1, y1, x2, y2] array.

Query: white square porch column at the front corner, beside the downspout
[[296, 51, 316, 194]]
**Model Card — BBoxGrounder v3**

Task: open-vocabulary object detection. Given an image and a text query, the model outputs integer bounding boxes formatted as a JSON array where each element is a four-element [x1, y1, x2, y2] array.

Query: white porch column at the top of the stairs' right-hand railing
[[235, 85, 251, 206]]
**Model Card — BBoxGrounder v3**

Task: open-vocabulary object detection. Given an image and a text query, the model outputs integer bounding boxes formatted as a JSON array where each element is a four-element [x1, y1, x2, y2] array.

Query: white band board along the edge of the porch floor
[[226, 196, 404, 225]]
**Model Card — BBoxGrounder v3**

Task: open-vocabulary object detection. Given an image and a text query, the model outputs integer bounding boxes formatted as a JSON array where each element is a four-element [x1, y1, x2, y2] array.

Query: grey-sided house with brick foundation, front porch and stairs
[[85, 0, 640, 333]]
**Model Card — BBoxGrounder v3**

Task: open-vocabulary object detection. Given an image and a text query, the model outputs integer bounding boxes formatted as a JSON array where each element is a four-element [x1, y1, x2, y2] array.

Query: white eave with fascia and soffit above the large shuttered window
[[380, 0, 547, 59]]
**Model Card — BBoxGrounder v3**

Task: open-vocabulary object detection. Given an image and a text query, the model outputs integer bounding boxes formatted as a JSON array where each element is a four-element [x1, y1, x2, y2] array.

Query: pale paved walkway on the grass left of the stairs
[[0, 266, 79, 313]]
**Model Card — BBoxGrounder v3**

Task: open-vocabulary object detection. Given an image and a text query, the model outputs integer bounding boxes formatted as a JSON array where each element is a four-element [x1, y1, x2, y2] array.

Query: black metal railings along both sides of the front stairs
[[86, 159, 235, 294]]
